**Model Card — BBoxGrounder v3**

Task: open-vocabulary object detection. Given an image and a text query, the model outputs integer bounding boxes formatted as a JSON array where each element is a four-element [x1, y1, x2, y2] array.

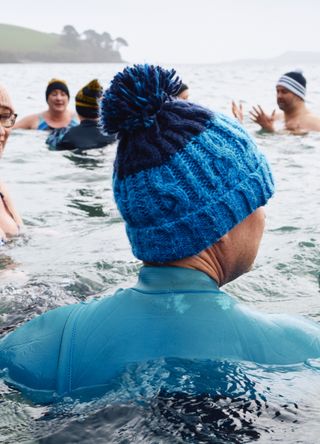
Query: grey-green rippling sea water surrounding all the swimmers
[[0, 62, 320, 444]]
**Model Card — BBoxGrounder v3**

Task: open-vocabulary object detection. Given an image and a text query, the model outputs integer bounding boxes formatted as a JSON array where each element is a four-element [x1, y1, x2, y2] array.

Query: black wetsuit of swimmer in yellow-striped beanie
[[56, 120, 116, 151]]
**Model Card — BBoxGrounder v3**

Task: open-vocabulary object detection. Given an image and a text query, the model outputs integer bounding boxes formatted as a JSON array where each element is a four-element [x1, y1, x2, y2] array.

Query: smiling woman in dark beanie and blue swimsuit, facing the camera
[[14, 78, 79, 131]]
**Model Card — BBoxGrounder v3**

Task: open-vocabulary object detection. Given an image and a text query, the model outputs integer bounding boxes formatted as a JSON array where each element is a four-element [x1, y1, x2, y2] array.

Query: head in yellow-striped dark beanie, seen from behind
[[76, 79, 103, 120]]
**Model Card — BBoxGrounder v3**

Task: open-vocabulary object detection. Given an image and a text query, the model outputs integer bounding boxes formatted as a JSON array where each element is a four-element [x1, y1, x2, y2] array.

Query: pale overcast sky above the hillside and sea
[[0, 0, 320, 64]]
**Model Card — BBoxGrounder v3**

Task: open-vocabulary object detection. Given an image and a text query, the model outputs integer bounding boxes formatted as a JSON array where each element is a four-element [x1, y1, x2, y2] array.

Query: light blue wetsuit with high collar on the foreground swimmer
[[0, 267, 320, 402]]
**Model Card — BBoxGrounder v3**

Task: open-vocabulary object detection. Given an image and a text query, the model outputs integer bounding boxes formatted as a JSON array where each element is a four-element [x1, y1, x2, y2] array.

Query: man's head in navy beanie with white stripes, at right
[[276, 71, 307, 112]]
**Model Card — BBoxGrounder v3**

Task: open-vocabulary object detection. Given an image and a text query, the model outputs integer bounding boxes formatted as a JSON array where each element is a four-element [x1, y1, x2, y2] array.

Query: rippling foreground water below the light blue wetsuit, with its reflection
[[0, 359, 320, 444]]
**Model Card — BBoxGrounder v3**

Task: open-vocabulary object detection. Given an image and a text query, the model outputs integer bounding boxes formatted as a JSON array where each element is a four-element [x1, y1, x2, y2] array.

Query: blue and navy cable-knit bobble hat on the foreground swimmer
[[100, 65, 274, 263]]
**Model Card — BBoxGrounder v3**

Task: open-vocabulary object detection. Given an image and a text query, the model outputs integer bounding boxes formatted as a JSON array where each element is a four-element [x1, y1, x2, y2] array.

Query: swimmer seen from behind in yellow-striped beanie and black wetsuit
[[54, 79, 115, 151]]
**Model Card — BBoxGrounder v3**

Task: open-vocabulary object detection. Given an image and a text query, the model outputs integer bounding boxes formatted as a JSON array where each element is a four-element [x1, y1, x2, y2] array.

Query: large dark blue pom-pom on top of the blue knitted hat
[[100, 65, 181, 134]]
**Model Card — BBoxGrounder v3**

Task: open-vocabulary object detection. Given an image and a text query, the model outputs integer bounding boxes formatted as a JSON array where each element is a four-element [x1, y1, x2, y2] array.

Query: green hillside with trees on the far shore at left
[[0, 24, 128, 63]]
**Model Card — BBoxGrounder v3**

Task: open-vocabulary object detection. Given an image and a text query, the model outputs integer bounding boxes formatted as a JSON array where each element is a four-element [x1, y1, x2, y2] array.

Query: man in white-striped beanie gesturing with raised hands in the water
[[232, 70, 320, 134]]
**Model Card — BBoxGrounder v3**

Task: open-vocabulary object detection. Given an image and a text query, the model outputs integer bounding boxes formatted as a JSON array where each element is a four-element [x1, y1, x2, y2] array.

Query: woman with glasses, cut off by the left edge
[[0, 85, 22, 245]]
